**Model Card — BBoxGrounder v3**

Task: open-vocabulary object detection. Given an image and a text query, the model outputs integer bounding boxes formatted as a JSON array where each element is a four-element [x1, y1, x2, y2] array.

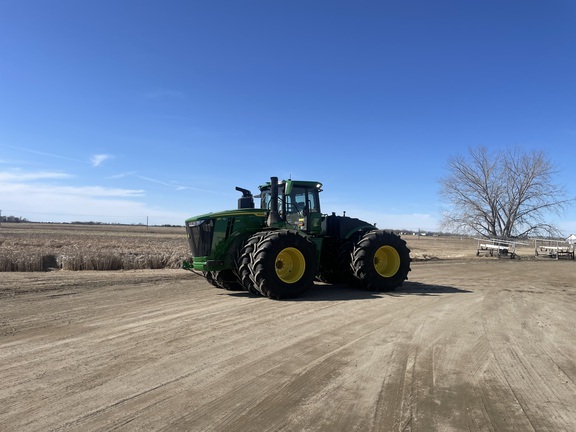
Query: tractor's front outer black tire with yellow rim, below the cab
[[250, 230, 317, 299]]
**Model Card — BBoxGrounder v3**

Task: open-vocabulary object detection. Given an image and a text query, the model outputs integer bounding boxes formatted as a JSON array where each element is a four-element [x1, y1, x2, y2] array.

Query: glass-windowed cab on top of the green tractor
[[259, 180, 322, 234]]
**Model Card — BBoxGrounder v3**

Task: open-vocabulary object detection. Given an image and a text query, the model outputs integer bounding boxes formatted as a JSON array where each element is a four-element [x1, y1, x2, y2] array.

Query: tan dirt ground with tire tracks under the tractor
[[0, 260, 576, 432]]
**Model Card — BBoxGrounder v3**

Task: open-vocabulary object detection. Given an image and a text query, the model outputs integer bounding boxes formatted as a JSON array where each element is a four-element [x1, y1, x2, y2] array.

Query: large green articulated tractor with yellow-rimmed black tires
[[183, 177, 411, 299]]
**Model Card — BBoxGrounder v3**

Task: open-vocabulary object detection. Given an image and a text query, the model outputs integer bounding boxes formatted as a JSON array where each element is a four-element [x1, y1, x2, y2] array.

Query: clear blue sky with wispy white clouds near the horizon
[[0, 0, 576, 234]]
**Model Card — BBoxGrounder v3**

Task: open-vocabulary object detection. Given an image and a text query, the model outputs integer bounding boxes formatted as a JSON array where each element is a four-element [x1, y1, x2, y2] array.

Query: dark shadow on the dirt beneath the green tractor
[[228, 282, 473, 302]]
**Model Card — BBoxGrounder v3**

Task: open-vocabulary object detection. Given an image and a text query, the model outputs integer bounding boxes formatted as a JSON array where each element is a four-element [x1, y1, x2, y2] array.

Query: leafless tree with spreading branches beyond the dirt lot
[[440, 147, 575, 238]]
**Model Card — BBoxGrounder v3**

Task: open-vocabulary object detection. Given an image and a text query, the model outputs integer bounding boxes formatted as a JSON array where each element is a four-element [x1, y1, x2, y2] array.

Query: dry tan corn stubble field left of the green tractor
[[0, 223, 188, 272]]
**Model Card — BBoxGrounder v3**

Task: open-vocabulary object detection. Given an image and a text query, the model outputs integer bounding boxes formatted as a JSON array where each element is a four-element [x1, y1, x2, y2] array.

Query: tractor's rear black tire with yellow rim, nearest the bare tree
[[352, 230, 411, 291]]
